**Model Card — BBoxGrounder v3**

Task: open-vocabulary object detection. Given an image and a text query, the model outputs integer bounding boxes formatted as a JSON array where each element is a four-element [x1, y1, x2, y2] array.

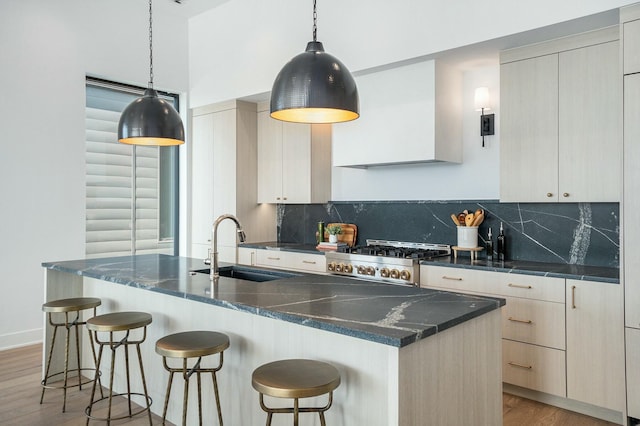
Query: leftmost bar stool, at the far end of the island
[[40, 297, 102, 413]]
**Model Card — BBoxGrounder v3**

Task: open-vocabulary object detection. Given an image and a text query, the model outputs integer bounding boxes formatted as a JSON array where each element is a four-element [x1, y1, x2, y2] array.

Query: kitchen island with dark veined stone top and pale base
[[43, 255, 504, 426]]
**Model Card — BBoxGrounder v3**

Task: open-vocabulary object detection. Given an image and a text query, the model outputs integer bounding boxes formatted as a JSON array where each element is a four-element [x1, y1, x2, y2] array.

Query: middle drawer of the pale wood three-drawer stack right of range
[[502, 297, 565, 350]]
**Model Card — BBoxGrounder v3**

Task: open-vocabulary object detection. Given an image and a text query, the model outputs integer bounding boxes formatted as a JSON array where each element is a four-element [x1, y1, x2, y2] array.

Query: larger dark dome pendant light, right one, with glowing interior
[[271, 0, 360, 123]]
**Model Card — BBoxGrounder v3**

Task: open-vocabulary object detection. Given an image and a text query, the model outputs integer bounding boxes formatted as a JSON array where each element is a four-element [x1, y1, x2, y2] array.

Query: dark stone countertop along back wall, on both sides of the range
[[242, 242, 620, 284]]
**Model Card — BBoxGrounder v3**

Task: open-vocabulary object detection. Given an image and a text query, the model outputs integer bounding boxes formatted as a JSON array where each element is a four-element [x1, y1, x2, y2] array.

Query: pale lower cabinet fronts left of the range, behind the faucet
[[238, 247, 327, 274]]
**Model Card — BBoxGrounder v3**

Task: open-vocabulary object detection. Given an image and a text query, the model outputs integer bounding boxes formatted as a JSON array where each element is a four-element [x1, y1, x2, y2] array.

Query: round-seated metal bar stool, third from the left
[[156, 331, 229, 426]]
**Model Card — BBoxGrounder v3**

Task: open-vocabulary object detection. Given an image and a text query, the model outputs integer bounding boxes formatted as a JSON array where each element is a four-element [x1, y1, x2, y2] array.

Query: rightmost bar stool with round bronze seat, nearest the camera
[[251, 359, 340, 426]]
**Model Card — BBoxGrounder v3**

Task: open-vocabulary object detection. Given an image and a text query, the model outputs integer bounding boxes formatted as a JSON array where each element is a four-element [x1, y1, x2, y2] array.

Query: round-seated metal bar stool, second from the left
[[84, 312, 152, 424]]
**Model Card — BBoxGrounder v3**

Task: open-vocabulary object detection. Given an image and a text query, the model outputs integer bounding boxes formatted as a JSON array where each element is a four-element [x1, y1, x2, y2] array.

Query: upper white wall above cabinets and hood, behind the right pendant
[[189, 0, 633, 107]]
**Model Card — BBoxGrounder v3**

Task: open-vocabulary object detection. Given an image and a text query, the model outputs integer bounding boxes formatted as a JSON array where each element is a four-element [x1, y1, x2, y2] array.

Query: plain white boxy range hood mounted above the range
[[333, 60, 462, 167]]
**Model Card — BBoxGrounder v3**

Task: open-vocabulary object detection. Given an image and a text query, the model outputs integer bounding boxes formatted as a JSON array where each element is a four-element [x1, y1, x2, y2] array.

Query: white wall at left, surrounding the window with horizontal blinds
[[0, 0, 188, 349]]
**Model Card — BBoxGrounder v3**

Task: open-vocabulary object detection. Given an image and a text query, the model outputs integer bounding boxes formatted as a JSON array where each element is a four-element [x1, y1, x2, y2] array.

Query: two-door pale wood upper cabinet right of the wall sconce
[[500, 27, 622, 203]]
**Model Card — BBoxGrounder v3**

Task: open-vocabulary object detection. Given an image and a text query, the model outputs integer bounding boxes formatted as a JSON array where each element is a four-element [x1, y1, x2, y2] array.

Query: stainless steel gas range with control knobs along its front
[[325, 240, 451, 286]]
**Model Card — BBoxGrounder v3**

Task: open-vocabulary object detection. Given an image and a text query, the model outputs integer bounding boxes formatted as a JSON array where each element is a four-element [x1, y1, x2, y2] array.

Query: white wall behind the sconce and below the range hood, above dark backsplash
[[331, 65, 500, 201]]
